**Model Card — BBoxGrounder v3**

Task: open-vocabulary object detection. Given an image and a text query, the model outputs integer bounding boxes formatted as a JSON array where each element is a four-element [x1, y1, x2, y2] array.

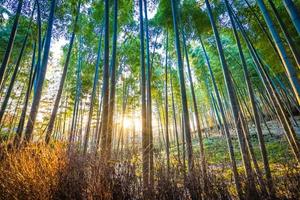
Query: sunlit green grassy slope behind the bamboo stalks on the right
[[203, 116, 300, 165]]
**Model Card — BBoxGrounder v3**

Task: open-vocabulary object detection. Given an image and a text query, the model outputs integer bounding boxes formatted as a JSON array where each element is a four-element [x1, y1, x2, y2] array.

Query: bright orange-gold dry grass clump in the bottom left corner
[[0, 145, 66, 199]]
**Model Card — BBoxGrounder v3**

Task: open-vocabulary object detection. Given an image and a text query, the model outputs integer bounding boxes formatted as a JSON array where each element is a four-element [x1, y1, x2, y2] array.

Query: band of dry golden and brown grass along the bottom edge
[[0, 143, 300, 200]]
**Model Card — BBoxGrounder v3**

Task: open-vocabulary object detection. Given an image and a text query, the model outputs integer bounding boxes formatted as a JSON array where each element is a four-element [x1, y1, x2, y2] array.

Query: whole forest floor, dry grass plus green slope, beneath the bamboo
[[0, 117, 300, 199]]
